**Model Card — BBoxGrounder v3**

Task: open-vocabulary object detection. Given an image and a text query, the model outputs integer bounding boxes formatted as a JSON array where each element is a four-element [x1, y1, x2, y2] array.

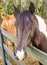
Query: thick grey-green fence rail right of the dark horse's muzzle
[[26, 46, 47, 65]]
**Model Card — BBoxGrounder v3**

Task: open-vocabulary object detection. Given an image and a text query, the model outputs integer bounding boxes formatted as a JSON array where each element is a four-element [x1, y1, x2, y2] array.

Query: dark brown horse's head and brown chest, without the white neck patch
[[13, 2, 47, 63]]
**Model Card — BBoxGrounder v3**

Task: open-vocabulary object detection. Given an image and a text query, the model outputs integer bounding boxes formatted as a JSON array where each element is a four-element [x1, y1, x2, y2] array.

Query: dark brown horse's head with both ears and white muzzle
[[14, 2, 38, 60]]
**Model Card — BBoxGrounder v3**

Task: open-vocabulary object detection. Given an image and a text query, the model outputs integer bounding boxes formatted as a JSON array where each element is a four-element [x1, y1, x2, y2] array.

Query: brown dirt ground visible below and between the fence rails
[[0, 54, 39, 65]]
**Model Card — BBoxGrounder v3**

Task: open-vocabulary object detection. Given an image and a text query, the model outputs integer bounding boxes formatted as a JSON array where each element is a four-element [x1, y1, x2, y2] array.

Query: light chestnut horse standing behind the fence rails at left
[[1, 14, 16, 51]]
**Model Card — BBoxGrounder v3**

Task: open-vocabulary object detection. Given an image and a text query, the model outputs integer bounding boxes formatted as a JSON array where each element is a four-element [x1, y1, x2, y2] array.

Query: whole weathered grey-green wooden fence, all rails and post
[[0, 28, 47, 65]]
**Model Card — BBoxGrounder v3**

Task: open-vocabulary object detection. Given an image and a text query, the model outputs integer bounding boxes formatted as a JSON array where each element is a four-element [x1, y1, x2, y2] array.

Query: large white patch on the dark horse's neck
[[35, 15, 47, 37]]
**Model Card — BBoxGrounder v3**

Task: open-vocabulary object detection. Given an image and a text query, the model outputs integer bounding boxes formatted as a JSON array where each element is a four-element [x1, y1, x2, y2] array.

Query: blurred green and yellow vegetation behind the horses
[[0, 0, 47, 24]]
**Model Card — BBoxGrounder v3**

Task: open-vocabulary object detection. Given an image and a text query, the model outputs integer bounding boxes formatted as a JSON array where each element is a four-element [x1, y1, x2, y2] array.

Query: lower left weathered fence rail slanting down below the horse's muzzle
[[4, 44, 25, 65]]
